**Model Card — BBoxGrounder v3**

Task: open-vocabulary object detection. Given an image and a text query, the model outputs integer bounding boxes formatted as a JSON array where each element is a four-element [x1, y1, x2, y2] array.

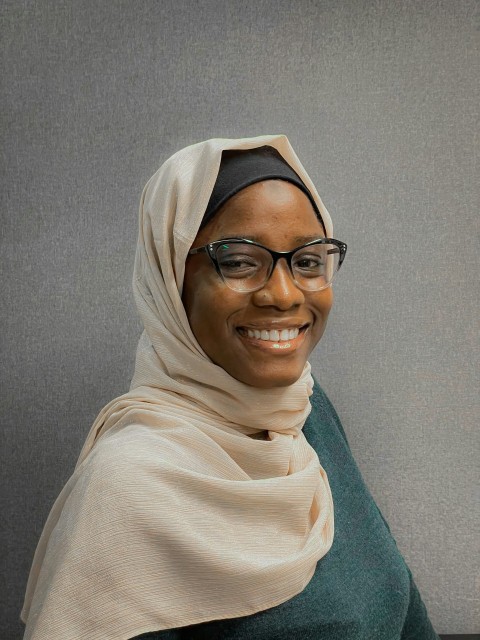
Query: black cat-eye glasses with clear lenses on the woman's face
[[188, 238, 347, 292]]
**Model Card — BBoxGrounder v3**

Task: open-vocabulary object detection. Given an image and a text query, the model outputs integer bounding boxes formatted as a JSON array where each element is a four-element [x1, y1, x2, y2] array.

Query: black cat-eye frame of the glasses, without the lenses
[[187, 238, 347, 293]]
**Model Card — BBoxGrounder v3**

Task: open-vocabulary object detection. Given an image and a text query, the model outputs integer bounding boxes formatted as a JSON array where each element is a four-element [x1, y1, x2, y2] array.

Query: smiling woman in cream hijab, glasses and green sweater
[[21, 135, 438, 640]]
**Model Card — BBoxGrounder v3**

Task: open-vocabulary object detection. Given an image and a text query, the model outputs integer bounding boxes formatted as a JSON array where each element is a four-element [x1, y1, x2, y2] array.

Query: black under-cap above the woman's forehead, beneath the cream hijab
[[200, 145, 326, 233]]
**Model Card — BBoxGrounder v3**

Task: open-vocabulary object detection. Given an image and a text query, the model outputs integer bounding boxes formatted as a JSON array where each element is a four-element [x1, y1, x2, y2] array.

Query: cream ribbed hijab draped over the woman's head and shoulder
[[21, 135, 334, 640]]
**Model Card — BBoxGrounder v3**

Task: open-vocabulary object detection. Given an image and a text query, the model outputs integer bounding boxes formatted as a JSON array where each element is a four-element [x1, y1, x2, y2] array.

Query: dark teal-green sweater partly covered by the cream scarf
[[131, 382, 439, 640]]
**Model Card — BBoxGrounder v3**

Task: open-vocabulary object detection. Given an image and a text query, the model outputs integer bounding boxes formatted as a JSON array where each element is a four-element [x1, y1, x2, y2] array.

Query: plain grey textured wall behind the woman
[[0, 0, 480, 640]]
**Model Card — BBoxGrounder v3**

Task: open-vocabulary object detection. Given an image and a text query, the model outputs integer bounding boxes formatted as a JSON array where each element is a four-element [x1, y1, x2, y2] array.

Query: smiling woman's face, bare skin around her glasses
[[182, 180, 333, 388]]
